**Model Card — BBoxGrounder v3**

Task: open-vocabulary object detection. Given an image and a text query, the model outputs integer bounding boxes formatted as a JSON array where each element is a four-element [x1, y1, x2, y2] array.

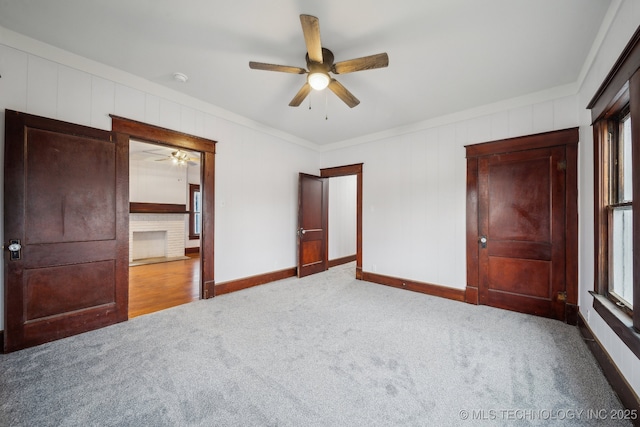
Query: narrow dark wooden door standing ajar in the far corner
[[298, 173, 328, 277]]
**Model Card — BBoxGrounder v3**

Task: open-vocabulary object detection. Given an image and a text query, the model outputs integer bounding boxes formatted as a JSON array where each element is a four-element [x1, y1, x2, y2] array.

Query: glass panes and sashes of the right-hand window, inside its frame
[[603, 106, 633, 314]]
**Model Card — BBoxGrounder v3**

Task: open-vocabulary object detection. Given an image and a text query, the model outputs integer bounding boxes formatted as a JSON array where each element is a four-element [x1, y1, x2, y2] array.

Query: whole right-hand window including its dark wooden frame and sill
[[587, 27, 640, 344]]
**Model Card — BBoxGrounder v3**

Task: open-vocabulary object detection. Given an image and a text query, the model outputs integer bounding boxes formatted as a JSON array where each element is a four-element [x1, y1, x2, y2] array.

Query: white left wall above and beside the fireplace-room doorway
[[0, 33, 319, 330]]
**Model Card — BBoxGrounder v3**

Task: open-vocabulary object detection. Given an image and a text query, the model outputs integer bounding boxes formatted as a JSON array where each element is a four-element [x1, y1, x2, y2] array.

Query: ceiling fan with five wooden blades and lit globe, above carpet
[[249, 15, 389, 108]]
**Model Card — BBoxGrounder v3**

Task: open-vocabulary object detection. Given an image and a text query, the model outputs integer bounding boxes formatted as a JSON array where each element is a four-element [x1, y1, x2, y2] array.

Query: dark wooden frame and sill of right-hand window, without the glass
[[587, 23, 640, 357]]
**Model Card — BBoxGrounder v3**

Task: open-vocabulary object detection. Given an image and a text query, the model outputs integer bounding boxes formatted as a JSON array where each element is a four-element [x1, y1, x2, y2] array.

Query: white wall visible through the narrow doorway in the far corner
[[329, 175, 357, 260]]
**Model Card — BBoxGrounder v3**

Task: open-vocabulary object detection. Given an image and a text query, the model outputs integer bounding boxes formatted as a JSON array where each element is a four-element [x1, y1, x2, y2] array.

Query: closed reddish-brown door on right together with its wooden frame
[[465, 128, 579, 324]]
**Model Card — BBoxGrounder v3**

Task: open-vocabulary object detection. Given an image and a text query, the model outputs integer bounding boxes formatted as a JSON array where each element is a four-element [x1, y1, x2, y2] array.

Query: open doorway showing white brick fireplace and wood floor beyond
[[129, 139, 202, 318]]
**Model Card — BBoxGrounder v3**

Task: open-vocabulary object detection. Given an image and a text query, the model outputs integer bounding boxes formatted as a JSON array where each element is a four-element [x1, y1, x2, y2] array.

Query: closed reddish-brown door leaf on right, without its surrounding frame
[[478, 146, 566, 320]]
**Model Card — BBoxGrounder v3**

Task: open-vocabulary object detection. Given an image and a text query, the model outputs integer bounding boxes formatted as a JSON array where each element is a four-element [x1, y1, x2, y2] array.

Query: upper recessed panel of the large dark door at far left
[[25, 128, 116, 244]]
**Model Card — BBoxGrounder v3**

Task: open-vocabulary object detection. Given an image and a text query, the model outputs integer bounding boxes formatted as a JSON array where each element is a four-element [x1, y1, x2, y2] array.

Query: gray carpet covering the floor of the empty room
[[0, 264, 630, 427]]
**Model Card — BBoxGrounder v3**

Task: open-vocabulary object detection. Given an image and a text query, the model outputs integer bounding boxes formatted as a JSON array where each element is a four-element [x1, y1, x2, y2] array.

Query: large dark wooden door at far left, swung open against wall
[[4, 111, 129, 351]]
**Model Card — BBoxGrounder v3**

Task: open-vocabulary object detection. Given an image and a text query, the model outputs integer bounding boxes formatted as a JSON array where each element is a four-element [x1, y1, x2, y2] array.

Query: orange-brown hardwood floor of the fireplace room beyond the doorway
[[129, 256, 200, 319]]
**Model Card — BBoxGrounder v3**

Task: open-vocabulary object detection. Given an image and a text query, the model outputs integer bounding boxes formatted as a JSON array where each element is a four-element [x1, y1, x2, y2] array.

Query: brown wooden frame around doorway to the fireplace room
[[110, 114, 217, 299]]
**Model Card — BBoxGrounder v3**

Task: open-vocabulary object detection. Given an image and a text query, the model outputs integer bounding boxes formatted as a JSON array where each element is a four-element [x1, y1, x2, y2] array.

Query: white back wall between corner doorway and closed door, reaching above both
[[322, 96, 578, 289]]
